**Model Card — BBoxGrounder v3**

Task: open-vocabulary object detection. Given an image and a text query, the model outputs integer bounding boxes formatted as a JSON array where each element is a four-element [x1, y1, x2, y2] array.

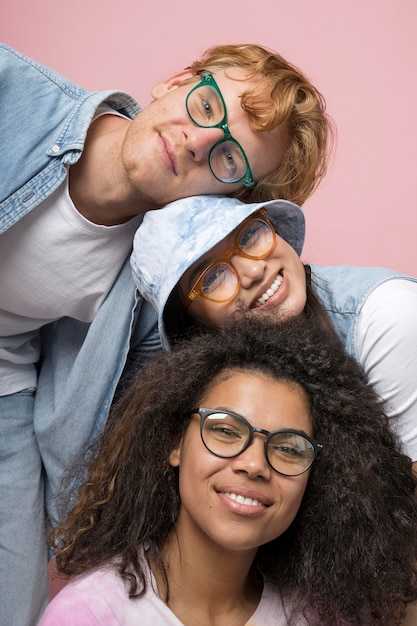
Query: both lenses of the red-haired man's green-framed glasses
[[186, 85, 247, 183]]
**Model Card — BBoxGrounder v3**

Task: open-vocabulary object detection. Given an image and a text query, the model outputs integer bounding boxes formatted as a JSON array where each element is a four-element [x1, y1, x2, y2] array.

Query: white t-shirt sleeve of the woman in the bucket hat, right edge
[[357, 279, 417, 461]]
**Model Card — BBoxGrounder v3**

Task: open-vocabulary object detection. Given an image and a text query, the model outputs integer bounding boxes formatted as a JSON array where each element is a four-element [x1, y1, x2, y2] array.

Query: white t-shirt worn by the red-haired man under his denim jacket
[[0, 180, 142, 395]]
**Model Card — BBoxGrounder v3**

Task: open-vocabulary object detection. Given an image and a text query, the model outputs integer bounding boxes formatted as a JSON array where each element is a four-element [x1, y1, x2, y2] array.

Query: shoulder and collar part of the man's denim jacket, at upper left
[[0, 44, 140, 233]]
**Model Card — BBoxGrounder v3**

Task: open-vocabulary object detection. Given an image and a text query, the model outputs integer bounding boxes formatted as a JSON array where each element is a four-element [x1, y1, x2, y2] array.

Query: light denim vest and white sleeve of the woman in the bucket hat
[[311, 266, 417, 461]]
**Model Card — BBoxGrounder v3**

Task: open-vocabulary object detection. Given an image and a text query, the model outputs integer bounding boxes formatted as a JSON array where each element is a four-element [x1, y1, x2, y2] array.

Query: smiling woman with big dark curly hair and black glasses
[[40, 319, 417, 626]]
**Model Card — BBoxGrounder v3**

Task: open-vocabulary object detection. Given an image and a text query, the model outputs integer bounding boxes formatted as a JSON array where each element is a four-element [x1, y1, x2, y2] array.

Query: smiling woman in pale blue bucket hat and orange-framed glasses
[[131, 196, 417, 478]]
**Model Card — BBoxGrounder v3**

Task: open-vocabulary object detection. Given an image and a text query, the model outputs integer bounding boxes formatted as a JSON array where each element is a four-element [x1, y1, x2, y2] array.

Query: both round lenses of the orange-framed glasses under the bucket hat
[[200, 219, 275, 302]]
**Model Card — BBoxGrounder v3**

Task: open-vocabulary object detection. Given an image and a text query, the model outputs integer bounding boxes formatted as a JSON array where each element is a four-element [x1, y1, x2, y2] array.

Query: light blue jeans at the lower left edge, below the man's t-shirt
[[0, 389, 49, 626]]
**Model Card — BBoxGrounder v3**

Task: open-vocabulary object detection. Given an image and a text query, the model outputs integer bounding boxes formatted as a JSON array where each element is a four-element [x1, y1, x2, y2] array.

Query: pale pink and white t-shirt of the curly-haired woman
[[39, 568, 300, 626]]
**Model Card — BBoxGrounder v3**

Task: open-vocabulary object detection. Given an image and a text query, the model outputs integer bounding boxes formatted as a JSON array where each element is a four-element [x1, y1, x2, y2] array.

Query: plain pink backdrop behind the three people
[[0, 0, 417, 275]]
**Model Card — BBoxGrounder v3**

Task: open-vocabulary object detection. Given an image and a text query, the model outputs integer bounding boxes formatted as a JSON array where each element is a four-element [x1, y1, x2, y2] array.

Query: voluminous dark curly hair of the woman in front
[[52, 318, 417, 626]]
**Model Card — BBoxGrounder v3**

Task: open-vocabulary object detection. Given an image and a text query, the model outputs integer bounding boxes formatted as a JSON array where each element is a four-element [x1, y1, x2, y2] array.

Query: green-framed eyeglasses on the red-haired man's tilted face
[[185, 72, 255, 187]]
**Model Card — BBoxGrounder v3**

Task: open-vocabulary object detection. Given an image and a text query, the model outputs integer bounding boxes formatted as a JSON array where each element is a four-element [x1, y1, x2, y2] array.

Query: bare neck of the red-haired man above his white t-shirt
[[69, 115, 149, 226]]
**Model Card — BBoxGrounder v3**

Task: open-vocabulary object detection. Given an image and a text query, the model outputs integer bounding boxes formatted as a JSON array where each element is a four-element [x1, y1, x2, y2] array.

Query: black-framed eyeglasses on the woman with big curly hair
[[193, 407, 323, 476]]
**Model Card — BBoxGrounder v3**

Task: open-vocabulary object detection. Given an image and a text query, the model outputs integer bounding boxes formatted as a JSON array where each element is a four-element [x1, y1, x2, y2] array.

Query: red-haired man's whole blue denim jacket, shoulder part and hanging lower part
[[0, 44, 159, 521]]
